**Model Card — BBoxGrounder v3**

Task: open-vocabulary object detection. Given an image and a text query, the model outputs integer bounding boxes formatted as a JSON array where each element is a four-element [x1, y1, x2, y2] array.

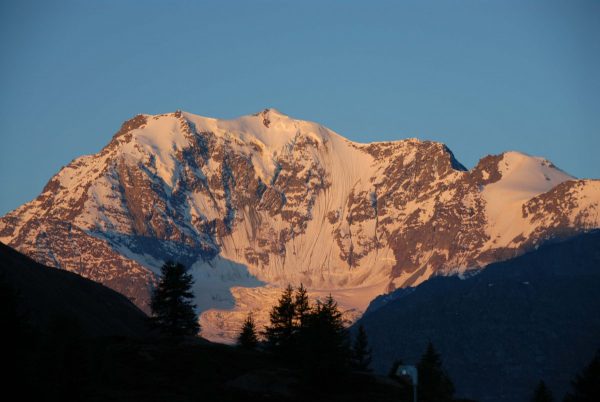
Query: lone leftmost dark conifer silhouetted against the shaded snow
[[150, 262, 200, 337]]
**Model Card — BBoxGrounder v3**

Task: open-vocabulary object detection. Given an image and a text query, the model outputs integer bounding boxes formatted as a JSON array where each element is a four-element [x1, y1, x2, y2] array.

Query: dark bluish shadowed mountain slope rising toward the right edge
[[360, 232, 600, 401]]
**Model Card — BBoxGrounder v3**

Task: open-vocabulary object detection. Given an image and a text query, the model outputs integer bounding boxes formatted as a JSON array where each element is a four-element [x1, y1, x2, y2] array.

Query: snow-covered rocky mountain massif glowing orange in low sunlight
[[0, 109, 600, 339]]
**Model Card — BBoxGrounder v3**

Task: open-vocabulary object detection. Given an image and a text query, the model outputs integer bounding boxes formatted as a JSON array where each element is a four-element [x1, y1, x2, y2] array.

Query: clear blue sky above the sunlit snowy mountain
[[0, 0, 600, 214]]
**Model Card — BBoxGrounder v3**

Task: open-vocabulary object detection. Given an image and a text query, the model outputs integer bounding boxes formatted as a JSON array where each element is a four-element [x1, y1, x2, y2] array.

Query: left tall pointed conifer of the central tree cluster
[[265, 285, 296, 351]]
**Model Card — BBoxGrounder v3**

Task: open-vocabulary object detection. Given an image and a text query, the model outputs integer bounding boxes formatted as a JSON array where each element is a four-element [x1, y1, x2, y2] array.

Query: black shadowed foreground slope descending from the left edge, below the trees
[[0, 244, 406, 402]]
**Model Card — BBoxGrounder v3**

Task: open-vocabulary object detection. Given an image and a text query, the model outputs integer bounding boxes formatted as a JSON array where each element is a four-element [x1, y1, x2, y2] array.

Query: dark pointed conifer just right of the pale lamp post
[[417, 342, 454, 402]]
